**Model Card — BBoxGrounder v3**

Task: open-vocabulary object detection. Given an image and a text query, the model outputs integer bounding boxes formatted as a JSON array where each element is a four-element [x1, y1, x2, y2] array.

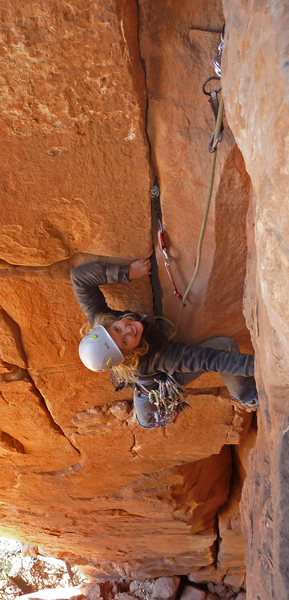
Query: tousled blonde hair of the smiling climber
[[80, 312, 149, 383]]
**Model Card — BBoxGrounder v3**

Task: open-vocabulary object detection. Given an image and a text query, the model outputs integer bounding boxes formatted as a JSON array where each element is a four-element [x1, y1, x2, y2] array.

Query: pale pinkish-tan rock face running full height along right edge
[[223, 1, 289, 600]]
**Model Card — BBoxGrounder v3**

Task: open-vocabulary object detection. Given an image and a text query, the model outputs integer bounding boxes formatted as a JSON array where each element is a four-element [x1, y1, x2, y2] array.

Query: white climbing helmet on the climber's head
[[78, 325, 124, 371]]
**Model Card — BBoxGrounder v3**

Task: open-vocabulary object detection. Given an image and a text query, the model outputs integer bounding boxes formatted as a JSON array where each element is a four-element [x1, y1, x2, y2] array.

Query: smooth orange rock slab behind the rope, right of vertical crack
[[140, 0, 250, 346]]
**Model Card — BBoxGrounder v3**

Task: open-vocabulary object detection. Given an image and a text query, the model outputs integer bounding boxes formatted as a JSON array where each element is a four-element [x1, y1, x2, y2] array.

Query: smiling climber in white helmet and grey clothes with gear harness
[[71, 258, 258, 428]]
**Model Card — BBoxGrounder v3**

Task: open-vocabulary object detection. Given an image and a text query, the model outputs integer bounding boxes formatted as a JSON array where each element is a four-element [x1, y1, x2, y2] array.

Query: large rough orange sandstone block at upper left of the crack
[[0, 0, 151, 266]]
